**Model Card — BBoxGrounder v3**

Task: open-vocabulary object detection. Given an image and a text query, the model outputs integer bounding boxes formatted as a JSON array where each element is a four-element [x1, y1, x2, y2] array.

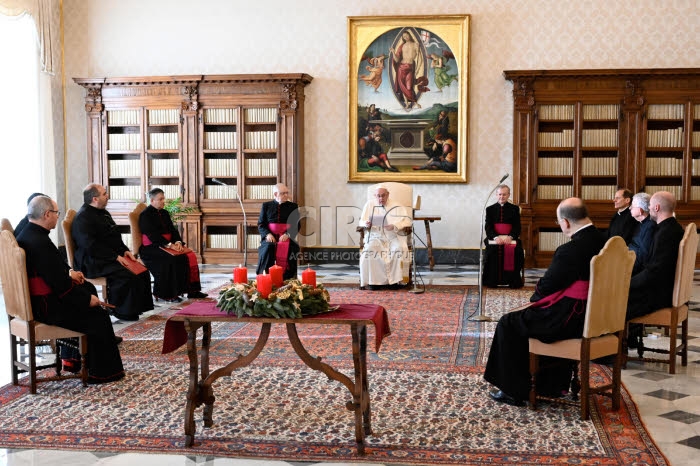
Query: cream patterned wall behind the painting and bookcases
[[63, 0, 700, 248]]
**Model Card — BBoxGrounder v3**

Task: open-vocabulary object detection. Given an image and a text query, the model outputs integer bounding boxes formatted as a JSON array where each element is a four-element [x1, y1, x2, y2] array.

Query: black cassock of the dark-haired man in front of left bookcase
[[139, 205, 202, 300]]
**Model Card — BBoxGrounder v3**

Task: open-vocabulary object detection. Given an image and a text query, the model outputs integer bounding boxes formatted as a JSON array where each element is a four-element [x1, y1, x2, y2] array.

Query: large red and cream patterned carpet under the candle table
[[0, 286, 667, 465]]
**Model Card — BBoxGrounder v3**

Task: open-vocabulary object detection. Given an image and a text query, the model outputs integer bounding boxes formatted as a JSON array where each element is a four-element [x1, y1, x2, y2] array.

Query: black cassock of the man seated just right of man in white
[[482, 202, 525, 288]]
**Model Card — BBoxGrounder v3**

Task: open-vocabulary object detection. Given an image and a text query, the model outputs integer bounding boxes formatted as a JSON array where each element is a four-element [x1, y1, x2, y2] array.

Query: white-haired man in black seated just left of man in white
[[256, 183, 300, 280]]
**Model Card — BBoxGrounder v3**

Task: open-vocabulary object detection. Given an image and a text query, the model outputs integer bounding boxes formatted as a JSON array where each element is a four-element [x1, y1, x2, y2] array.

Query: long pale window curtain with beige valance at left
[[0, 0, 66, 244]]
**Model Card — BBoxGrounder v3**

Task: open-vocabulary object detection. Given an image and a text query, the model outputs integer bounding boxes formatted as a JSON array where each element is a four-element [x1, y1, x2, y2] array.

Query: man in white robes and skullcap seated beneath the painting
[[359, 185, 412, 290]]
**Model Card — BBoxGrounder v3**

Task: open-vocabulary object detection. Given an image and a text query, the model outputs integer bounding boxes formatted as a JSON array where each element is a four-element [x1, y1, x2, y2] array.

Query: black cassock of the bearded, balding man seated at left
[[72, 204, 153, 320]]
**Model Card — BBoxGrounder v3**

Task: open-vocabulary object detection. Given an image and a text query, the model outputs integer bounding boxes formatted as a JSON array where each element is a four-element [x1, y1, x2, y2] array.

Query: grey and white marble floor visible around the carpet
[[0, 264, 700, 466]]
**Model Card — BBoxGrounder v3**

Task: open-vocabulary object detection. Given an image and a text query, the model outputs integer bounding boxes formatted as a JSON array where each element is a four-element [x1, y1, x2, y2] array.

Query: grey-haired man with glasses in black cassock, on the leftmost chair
[[17, 195, 124, 384]]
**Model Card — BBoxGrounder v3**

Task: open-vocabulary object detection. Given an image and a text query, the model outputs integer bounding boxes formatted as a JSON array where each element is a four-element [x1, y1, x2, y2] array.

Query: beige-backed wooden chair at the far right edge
[[624, 223, 698, 374]]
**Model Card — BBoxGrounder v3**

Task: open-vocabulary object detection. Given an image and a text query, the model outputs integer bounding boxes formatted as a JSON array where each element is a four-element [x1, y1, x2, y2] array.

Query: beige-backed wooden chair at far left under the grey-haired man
[[0, 230, 88, 394]]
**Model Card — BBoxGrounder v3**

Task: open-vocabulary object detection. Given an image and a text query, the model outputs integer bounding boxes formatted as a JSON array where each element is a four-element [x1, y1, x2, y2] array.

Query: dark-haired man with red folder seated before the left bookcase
[[139, 188, 207, 302]]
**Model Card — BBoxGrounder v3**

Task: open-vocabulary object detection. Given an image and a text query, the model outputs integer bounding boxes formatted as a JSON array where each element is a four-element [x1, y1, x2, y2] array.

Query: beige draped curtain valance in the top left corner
[[0, 0, 60, 74]]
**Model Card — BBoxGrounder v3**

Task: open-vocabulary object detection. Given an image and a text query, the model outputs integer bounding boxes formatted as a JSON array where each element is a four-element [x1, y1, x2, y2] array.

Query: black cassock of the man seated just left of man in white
[[256, 200, 299, 280]]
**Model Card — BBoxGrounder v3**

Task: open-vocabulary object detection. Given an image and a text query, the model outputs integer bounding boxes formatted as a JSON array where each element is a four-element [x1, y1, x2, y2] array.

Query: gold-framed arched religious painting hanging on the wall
[[348, 15, 470, 183]]
